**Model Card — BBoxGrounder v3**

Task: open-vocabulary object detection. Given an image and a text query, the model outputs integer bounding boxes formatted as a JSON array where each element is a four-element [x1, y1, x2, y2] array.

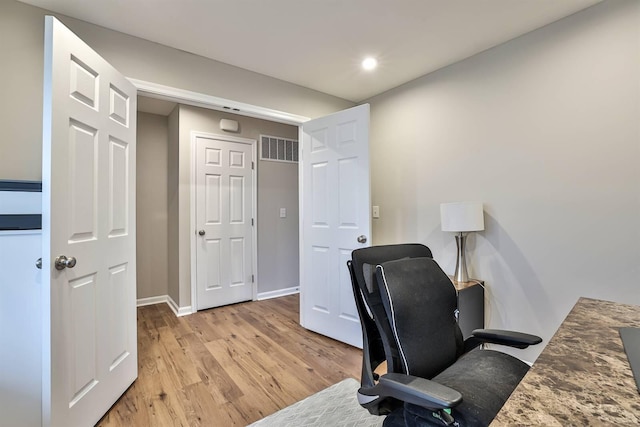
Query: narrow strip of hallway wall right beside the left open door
[[136, 112, 169, 299]]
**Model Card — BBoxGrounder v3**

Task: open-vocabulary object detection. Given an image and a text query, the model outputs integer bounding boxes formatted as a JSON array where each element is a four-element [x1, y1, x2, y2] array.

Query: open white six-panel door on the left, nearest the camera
[[42, 16, 138, 426]]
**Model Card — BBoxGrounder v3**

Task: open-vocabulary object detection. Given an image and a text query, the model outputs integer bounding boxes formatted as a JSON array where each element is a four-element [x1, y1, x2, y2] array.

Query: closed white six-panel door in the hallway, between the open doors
[[193, 134, 255, 310]]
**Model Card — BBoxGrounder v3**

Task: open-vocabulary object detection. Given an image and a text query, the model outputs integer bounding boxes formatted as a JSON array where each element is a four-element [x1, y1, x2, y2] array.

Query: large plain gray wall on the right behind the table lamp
[[369, 0, 640, 361]]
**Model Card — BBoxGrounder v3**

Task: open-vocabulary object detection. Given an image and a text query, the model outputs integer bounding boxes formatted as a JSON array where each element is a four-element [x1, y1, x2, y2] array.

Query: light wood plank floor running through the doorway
[[98, 295, 362, 427]]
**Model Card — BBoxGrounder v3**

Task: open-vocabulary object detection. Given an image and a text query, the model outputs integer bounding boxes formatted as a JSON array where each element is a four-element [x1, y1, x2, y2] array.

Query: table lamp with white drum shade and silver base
[[440, 202, 484, 283]]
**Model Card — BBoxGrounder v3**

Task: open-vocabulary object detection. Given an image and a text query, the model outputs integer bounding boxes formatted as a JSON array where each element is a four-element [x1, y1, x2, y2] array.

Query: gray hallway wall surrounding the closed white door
[[169, 105, 298, 307]]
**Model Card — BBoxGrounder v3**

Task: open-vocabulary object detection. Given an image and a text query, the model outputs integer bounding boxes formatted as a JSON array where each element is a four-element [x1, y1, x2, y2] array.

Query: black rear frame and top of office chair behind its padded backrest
[[348, 243, 432, 386]]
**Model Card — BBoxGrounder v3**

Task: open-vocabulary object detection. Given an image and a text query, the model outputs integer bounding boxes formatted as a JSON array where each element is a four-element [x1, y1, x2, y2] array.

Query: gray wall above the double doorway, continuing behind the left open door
[[0, 0, 353, 180]]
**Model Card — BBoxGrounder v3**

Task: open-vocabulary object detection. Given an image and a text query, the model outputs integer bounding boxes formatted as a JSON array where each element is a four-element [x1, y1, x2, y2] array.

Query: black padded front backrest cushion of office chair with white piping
[[376, 258, 463, 379]]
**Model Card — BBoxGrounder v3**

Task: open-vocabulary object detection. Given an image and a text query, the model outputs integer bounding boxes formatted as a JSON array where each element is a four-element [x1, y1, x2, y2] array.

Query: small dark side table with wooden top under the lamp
[[449, 276, 484, 339]]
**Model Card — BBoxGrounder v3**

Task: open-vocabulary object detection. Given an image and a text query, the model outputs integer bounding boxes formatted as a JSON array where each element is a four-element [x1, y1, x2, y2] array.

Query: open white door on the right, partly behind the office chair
[[300, 104, 371, 347]]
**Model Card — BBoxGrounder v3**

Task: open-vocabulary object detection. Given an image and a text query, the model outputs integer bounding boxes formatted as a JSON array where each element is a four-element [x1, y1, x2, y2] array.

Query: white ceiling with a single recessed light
[[20, 0, 601, 102]]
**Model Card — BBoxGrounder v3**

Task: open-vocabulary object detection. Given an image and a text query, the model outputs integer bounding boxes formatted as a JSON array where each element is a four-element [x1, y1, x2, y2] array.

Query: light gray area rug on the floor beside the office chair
[[251, 378, 384, 427]]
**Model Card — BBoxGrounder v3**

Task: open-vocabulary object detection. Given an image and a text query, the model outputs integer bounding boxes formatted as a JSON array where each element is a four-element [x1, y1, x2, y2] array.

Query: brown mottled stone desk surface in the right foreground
[[491, 298, 640, 427]]
